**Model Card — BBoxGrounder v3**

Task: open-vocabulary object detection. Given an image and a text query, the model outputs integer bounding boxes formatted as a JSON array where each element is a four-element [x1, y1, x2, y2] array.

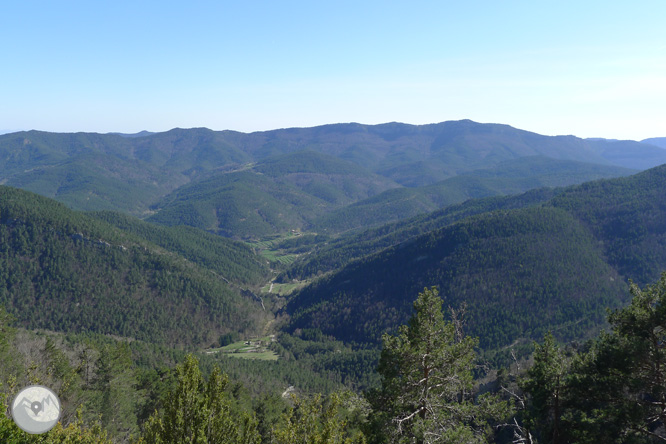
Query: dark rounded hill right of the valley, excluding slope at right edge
[[288, 208, 626, 349]]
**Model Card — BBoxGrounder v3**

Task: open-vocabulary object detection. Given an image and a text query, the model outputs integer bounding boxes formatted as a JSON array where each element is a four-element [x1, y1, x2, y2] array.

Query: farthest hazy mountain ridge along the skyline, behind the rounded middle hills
[[0, 120, 666, 229]]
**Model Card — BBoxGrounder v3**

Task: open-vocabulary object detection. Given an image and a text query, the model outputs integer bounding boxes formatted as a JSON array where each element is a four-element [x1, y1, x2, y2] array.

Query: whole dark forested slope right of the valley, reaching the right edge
[[288, 166, 666, 354]]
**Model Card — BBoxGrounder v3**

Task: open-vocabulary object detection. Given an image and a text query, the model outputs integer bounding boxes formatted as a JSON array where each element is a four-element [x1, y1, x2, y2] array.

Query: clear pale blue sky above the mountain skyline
[[0, 0, 666, 139]]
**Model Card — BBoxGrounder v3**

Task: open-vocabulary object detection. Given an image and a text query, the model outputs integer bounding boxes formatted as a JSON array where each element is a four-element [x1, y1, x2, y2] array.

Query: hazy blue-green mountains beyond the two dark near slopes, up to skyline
[[0, 120, 666, 238]]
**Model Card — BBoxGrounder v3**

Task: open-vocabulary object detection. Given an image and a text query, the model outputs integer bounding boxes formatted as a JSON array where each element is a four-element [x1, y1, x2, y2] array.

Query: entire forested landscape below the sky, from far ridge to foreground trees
[[0, 121, 666, 443]]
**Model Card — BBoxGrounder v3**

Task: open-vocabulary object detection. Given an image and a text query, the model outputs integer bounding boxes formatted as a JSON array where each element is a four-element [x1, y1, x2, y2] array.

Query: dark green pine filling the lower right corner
[[564, 273, 666, 443]]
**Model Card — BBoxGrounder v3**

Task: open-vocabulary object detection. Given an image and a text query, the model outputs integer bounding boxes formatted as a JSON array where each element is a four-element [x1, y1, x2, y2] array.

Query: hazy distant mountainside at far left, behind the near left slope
[[0, 129, 248, 215]]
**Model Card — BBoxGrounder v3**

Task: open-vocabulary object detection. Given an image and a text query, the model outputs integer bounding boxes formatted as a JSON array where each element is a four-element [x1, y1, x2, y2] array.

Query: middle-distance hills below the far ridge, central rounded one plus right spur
[[150, 151, 632, 238]]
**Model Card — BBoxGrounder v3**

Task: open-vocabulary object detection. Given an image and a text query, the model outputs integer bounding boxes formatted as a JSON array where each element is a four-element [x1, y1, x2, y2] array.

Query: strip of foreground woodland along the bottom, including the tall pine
[[0, 280, 666, 443]]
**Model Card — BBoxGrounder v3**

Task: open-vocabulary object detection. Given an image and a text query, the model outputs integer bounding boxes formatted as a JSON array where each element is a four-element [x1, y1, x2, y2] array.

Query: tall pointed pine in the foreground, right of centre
[[370, 287, 508, 443]]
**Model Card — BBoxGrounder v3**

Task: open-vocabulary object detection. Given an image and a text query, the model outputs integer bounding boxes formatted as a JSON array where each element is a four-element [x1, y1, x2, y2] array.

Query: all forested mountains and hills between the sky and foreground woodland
[[0, 121, 666, 362]]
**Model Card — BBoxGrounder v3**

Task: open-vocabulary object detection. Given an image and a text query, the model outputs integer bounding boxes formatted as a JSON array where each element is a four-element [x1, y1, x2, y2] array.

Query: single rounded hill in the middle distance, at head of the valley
[[149, 151, 396, 239]]
